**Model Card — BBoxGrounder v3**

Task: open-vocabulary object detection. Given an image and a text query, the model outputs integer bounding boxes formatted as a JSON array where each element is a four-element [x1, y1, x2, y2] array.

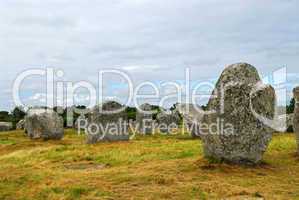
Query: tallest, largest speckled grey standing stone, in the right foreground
[[201, 63, 276, 164]]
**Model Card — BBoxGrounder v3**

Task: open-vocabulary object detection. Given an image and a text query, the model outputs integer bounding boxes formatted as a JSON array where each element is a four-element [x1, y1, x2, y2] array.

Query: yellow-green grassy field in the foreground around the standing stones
[[0, 130, 299, 200]]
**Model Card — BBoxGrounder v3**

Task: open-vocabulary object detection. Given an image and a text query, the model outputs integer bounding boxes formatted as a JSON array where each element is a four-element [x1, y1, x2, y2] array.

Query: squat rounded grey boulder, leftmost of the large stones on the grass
[[25, 108, 64, 140]]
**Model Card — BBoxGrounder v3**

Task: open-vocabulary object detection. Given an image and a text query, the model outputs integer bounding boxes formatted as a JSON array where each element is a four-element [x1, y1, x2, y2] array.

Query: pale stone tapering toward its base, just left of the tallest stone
[[177, 104, 204, 138]]
